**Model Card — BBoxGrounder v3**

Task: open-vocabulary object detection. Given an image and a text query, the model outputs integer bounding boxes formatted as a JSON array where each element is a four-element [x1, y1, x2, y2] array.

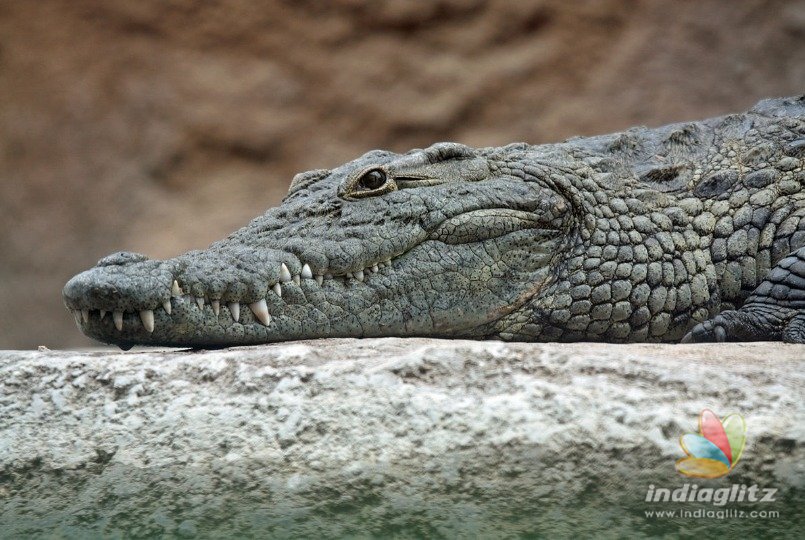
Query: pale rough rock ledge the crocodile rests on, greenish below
[[0, 339, 805, 538]]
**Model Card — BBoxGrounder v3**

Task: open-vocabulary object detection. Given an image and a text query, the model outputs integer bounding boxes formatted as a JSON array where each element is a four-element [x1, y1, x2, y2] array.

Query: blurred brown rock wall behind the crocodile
[[0, 0, 805, 348]]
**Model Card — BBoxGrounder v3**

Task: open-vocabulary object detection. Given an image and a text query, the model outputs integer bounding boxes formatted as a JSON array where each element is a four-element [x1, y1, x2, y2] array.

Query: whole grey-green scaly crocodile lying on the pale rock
[[64, 96, 805, 348]]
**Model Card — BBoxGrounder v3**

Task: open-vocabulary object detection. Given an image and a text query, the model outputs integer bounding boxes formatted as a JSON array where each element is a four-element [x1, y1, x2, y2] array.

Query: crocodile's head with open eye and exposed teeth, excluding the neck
[[63, 143, 571, 348]]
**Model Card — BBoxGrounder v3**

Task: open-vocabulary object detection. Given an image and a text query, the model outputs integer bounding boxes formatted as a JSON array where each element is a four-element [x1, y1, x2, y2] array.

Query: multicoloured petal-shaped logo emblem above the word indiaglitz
[[676, 409, 746, 478]]
